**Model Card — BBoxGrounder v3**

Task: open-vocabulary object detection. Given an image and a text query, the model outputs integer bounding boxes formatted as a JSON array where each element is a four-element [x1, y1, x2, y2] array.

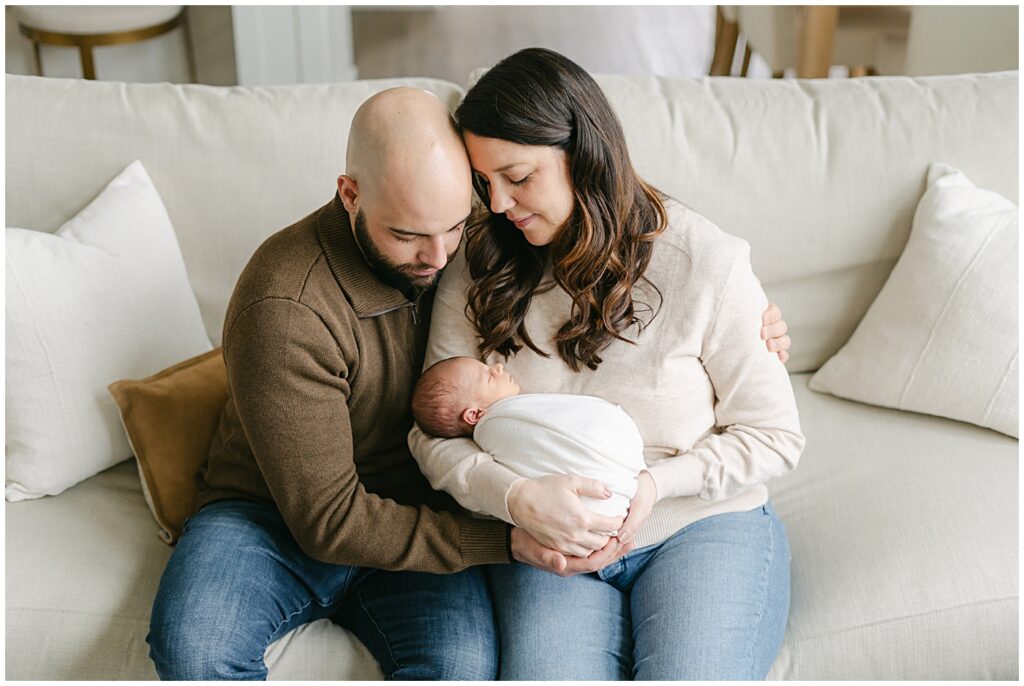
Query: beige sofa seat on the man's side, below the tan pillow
[[5, 461, 381, 680]]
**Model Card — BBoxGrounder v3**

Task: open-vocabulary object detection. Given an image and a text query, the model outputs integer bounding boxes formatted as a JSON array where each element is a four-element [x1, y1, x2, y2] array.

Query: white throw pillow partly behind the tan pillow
[[4, 161, 212, 501]]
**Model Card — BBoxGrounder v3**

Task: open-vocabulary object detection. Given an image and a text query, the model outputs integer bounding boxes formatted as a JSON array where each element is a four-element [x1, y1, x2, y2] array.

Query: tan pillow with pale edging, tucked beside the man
[[108, 348, 227, 545]]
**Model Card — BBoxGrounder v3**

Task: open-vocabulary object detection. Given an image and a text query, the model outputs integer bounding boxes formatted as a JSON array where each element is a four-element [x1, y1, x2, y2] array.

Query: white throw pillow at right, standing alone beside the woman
[[810, 164, 1019, 436]]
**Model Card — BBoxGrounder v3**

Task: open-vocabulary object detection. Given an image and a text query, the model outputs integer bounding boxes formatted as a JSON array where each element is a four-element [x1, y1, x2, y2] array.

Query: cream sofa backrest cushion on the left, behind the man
[[6, 75, 462, 344]]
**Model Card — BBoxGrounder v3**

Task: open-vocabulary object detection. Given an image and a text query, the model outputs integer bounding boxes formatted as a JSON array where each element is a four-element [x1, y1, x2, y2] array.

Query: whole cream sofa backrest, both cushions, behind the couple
[[6, 72, 1018, 372]]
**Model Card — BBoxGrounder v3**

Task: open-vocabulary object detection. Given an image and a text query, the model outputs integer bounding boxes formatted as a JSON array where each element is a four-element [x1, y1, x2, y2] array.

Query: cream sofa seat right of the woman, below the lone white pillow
[[770, 375, 1019, 680]]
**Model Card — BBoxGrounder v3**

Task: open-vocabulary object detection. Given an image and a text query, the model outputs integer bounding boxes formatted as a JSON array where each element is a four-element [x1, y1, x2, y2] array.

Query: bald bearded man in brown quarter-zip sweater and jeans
[[147, 88, 788, 680]]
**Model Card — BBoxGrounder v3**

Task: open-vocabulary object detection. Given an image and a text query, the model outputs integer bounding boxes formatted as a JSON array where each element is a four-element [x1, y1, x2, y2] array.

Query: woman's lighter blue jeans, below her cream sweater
[[487, 505, 790, 680]]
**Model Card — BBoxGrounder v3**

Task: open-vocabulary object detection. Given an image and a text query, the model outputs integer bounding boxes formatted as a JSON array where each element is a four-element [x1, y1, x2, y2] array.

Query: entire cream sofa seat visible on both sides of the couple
[[6, 374, 1018, 680]]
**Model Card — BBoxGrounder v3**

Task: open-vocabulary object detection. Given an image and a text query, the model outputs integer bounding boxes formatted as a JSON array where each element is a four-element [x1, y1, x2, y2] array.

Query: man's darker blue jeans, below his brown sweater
[[146, 501, 498, 680]]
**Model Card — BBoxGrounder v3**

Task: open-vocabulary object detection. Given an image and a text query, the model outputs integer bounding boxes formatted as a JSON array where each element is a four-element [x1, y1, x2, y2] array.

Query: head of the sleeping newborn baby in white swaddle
[[413, 357, 519, 438]]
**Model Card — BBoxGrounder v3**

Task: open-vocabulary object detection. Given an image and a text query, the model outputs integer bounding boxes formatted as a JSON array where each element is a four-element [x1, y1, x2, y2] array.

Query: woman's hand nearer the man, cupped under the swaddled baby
[[508, 474, 623, 558]]
